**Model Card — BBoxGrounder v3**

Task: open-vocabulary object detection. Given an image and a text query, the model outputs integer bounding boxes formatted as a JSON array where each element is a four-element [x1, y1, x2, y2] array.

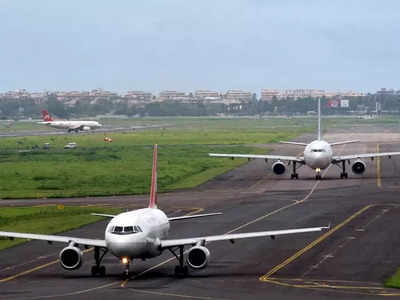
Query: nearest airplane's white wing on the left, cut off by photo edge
[[0, 231, 107, 248]]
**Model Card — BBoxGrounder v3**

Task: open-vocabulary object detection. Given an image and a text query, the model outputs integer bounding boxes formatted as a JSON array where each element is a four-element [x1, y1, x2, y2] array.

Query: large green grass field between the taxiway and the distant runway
[[0, 118, 310, 199]]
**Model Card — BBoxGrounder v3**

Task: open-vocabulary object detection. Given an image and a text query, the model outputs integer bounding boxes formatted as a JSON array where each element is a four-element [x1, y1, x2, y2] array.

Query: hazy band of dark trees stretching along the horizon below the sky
[[0, 95, 400, 119]]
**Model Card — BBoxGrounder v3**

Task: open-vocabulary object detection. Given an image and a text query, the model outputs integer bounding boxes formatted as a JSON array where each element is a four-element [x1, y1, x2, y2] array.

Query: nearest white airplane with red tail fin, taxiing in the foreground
[[0, 145, 330, 277]]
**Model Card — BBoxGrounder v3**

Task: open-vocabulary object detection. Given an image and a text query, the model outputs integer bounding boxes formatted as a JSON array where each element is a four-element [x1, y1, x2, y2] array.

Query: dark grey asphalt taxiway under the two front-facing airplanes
[[0, 129, 400, 299]]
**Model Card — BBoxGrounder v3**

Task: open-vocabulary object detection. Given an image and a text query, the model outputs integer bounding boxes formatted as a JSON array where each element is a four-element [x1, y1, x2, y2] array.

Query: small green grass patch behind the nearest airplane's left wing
[[0, 205, 121, 250]]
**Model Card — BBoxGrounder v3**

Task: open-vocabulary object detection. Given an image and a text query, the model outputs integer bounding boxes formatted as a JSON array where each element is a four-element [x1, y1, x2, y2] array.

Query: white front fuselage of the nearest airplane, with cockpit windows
[[105, 208, 170, 259]]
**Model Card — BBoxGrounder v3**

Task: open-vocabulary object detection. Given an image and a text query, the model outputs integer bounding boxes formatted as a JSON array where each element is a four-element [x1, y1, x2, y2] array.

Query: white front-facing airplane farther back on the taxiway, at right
[[208, 99, 400, 180]]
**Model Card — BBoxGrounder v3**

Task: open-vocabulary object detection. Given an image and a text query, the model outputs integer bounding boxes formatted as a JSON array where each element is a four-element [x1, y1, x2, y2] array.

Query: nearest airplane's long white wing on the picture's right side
[[161, 227, 330, 249]]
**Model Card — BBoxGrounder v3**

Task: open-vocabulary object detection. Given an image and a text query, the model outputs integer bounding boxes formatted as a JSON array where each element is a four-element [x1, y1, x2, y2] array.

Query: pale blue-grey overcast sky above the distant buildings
[[0, 0, 400, 93]]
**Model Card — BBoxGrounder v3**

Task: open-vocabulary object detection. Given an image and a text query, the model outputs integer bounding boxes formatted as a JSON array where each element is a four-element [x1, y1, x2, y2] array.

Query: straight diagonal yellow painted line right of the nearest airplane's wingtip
[[260, 204, 374, 281]]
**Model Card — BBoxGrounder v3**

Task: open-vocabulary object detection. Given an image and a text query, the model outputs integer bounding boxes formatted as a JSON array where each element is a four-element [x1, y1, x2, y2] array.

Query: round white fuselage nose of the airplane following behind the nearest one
[[304, 140, 333, 170]]
